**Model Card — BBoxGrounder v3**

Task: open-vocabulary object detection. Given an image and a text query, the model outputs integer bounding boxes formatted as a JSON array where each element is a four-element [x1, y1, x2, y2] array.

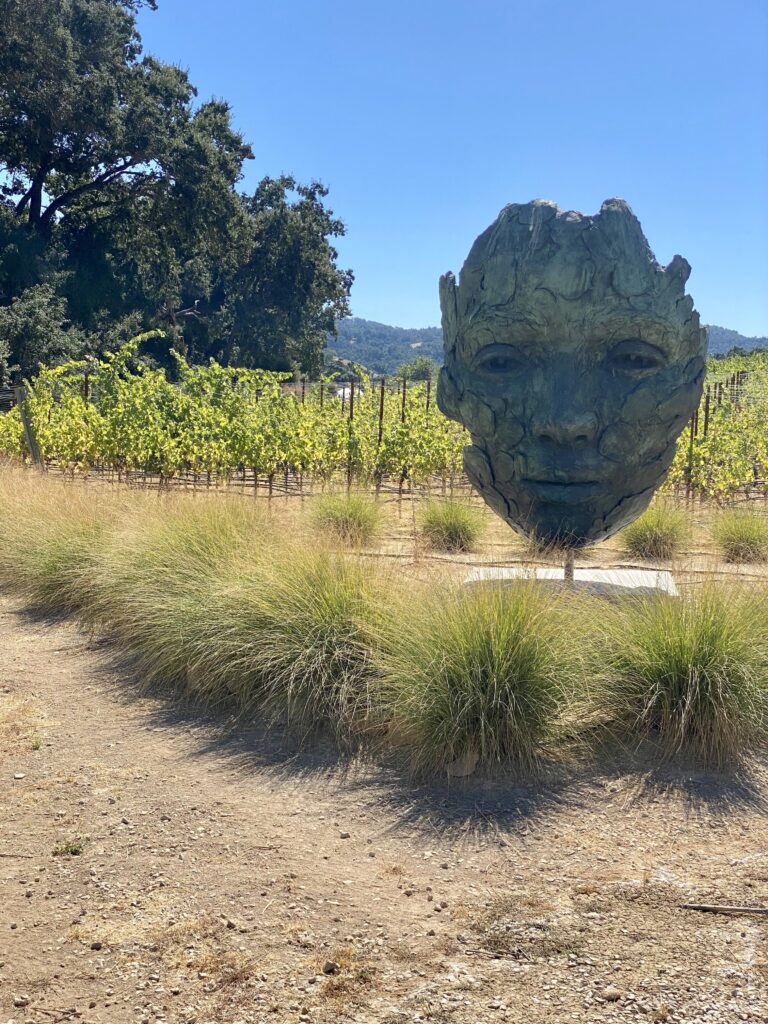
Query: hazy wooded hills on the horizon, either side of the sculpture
[[327, 316, 768, 374]]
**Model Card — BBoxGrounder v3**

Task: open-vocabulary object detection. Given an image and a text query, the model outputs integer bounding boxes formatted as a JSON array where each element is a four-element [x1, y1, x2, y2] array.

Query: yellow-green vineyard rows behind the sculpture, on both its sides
[[0, 336, 768, 498]]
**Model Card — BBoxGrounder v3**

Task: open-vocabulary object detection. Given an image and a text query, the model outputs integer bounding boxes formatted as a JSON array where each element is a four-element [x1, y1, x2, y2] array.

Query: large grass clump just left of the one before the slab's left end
[[208, 545, 386, 743]]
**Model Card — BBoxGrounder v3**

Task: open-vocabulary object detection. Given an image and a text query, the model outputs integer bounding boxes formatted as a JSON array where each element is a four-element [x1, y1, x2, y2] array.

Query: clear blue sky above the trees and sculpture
[[139, 0, 768, 335]]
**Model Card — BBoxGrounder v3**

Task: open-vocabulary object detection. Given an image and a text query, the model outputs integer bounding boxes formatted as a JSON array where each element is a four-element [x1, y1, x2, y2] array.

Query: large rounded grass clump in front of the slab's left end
[[377, 582, 575, 775]]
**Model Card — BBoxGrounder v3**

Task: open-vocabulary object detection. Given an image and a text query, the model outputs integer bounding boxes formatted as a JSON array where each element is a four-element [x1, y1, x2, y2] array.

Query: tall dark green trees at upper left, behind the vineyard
[[0, 0, 352, 375]]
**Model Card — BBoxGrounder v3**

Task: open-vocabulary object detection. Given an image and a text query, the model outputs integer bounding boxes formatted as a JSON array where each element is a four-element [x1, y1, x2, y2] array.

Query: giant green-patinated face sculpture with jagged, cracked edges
[[437, 200, 707, 548]]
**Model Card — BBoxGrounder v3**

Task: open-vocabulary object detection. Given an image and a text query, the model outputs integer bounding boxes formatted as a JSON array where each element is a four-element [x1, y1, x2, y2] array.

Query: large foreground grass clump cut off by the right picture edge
[[593, 585, 768, 766]]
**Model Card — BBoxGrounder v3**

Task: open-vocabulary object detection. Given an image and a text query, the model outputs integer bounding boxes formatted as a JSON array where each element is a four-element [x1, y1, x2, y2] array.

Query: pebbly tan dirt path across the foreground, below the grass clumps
[[0, 598, 768, 1024]]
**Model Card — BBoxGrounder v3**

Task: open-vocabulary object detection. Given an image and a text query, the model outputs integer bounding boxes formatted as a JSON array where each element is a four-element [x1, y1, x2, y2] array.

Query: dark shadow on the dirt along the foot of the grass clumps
[[12, 609, 768, 844]]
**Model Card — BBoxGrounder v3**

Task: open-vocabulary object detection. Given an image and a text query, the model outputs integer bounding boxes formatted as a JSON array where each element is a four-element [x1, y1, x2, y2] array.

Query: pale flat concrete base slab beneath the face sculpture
[[464, 565, 679, 597]]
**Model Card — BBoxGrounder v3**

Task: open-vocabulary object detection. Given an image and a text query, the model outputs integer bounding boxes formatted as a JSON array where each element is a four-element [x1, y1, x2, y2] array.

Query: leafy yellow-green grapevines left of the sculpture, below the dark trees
[[0, 334, 464, 482]]
